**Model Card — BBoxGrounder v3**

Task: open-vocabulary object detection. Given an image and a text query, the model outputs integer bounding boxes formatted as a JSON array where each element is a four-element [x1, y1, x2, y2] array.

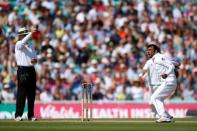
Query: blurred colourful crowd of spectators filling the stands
[[0, 0, 197, 102]]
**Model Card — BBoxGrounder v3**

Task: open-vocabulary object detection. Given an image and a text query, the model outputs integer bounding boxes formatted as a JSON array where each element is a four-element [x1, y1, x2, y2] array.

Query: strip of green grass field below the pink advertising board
[[0, 118, 197, 131]]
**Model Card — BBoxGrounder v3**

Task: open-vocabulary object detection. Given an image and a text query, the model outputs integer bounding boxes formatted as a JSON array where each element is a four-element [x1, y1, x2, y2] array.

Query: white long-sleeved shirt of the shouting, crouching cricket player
[[143, 53, 176, 86]]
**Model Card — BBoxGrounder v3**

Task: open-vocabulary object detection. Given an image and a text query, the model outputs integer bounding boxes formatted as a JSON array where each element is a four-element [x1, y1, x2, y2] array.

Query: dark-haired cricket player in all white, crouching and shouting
[[140, 44, 177, 122]]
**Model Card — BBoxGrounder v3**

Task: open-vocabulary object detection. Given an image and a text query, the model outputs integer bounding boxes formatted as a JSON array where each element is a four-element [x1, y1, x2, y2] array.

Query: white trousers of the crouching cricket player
[[151, 82, 176, 117]]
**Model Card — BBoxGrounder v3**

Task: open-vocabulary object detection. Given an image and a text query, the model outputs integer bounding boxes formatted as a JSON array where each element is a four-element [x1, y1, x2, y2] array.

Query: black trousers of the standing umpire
[[15, 66, 36, 118]]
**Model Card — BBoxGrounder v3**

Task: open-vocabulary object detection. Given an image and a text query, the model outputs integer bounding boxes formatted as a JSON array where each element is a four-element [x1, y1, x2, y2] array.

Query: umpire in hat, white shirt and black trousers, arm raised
[[15, 27, 37, 121]]
